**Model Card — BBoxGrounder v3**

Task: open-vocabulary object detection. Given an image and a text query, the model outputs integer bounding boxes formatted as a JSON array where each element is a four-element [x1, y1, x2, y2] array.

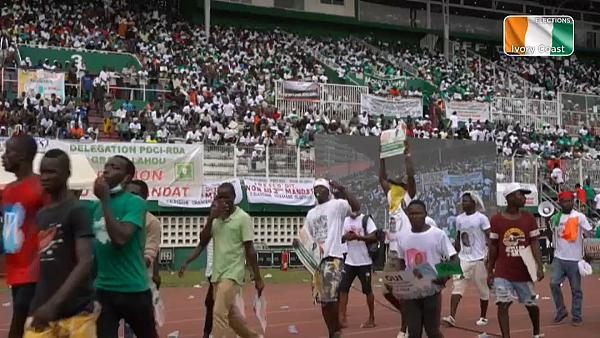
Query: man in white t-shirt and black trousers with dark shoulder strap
[[340, 213, 377, 329]]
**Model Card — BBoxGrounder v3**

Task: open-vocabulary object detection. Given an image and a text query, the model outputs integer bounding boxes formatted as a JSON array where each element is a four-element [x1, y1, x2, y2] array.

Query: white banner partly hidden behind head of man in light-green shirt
[[158, 178, 244, 208]]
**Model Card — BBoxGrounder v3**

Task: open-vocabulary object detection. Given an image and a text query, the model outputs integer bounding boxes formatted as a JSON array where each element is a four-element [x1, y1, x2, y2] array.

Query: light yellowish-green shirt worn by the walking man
[[211, 207, 254, 285]]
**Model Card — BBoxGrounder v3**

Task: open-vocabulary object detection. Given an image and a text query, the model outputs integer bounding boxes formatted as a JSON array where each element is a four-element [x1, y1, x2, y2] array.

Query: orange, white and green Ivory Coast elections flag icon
[[504, 15, 575, 56]]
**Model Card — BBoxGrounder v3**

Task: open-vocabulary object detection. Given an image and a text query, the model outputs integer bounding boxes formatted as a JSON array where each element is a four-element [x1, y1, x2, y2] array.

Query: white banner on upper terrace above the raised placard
[[360, 94, 423, 118]]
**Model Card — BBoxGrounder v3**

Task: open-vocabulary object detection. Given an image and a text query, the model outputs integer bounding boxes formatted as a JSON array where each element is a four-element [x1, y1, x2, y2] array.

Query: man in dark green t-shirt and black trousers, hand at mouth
[[91, 155, 158, 338]]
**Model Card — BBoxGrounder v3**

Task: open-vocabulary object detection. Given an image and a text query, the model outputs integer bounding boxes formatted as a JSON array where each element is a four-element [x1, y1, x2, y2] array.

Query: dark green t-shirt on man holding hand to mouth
[[90, 191, 149, 292]]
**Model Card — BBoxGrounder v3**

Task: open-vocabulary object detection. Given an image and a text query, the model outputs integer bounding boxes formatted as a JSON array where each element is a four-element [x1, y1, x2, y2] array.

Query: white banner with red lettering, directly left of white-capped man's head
[[244, 179, 316, 206]]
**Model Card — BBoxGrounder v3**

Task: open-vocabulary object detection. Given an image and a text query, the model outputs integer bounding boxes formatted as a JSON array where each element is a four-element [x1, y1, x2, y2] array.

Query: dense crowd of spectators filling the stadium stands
[[0, 1, 600, 162]]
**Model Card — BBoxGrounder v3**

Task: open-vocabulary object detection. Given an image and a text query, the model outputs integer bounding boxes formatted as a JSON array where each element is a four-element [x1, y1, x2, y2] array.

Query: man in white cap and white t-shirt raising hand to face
[[304, 179, 360, 337]]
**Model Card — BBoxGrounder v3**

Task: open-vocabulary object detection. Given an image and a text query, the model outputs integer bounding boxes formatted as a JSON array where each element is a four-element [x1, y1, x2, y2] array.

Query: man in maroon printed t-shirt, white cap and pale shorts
[[488, 183, 544, 338]]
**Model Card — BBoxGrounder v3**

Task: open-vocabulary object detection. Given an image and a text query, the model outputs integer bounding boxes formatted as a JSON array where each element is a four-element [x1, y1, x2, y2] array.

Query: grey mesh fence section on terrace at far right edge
[[558, 92, 600, 134]]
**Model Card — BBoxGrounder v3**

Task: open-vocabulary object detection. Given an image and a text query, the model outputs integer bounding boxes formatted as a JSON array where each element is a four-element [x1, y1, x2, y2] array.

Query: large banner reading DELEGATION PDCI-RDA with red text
[[44, 140, 204, 200]]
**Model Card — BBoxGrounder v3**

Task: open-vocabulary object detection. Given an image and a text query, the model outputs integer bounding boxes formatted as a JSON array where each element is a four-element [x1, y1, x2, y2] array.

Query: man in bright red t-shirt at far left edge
[[2, 136, 44, 338]]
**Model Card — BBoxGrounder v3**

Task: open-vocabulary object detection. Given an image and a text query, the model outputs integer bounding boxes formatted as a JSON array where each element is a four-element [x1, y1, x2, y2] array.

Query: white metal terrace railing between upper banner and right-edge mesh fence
[[491, 97, 561, 127]]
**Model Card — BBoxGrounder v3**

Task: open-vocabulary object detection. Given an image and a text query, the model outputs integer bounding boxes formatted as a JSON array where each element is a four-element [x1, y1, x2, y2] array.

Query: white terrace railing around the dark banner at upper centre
[[275, 81, 369, 121]]
